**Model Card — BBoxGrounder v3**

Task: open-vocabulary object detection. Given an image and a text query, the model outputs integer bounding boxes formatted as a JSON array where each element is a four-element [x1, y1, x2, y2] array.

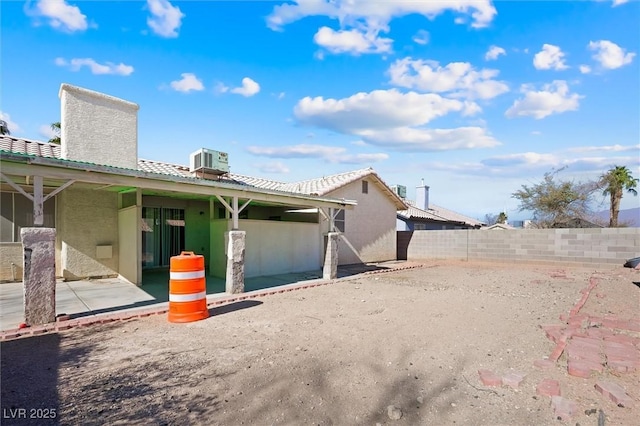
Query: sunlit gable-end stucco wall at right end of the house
[[325, 178, 396, 265]]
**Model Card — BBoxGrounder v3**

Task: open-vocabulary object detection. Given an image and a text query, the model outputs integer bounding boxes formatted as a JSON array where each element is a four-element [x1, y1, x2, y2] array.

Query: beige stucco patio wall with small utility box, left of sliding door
[[57, 188, 119, 279]]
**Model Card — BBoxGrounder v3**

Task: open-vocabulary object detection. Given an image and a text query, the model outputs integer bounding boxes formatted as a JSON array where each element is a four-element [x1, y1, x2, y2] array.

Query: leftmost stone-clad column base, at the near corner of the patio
[[20, 228, 56, 325]]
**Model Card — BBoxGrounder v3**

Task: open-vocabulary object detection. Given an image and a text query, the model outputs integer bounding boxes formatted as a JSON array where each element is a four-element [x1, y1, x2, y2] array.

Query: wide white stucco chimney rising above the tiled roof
[[58, 83, 139, 169]]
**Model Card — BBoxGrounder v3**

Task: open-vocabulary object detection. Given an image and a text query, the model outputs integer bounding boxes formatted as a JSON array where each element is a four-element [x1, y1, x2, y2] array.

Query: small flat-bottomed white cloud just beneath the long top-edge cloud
[[313, 27, 393, 55]]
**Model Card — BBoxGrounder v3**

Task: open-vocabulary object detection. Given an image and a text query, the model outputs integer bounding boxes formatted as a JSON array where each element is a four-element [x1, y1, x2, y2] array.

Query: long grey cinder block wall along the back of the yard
[[407, 228, 640, 266]]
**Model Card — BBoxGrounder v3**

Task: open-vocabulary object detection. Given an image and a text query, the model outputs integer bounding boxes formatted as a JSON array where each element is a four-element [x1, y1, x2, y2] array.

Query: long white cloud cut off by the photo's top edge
[[267, 0, 497, 30]]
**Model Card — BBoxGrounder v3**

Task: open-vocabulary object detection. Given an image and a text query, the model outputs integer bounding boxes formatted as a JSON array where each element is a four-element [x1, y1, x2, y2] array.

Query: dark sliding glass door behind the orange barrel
[[142, 207, 184, 268]]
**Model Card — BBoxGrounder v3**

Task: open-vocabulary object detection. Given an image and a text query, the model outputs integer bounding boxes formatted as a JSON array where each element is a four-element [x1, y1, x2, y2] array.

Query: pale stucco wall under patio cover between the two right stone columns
[[239, 220, 321, 278]]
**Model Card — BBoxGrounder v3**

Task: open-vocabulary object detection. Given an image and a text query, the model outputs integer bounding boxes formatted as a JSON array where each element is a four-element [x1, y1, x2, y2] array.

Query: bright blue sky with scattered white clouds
[[0, 0, 640, 219]]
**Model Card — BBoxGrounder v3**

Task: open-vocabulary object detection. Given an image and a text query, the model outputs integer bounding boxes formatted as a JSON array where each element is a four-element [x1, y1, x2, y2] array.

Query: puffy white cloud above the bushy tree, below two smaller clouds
[[505, 80, 584, 120]]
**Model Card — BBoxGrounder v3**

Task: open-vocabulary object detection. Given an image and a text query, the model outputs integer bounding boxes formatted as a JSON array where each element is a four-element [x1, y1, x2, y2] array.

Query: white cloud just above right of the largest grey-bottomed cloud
[[388, 58, 509, 99]]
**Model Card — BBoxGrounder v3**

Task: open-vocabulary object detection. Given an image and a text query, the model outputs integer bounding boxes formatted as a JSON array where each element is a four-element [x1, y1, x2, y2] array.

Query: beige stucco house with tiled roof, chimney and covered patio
[[0, 84, 406, 284]]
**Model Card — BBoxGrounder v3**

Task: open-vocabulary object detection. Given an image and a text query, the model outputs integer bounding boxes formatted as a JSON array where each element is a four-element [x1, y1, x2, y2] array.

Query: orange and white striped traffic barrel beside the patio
[[169, 251, 209, 322]]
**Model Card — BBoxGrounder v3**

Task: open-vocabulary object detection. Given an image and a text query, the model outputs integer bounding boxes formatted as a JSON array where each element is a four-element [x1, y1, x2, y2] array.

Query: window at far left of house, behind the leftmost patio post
[[0, 192, 56, 243]]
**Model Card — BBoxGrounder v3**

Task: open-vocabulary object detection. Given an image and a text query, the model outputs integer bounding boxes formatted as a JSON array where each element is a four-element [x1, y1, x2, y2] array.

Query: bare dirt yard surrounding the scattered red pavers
[[1, 262, 640, 426]]
